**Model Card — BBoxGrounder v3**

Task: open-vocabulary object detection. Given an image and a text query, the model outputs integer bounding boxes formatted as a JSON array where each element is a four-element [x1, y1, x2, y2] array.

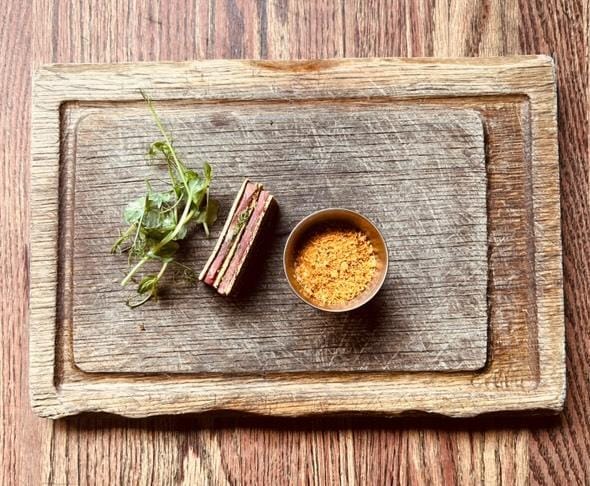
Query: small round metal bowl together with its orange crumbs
[[283, 208, 389, 312]]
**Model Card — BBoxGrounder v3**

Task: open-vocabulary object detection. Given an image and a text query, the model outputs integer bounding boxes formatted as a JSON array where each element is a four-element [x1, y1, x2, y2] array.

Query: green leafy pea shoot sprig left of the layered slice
[[111, 91, 219, 307]]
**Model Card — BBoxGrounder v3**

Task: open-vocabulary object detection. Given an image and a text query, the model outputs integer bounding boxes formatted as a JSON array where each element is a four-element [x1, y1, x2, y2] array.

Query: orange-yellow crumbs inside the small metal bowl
[[295, 227, 377, 305]]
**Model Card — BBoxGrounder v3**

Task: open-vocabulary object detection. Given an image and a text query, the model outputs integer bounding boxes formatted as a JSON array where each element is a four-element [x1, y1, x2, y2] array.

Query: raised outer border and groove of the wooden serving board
[[31, 57, 564, 416]]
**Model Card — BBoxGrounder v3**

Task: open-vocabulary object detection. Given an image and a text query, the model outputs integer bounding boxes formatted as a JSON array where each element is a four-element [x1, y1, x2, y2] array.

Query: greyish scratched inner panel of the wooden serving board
[[69, 102, 488, 373]]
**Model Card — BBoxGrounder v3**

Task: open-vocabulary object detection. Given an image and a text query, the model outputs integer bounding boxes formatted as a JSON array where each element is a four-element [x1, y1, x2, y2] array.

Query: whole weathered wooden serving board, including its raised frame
[[30, 57, 564, 417]]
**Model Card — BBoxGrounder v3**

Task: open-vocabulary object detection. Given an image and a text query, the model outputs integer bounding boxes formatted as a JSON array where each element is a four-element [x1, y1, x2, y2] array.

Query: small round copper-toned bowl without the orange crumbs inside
[[283, 208, 389, 312]]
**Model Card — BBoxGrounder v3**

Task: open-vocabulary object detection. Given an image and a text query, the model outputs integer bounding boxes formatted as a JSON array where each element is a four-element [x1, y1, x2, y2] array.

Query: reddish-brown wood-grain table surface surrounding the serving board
[[0, 0, 590, 485]]
